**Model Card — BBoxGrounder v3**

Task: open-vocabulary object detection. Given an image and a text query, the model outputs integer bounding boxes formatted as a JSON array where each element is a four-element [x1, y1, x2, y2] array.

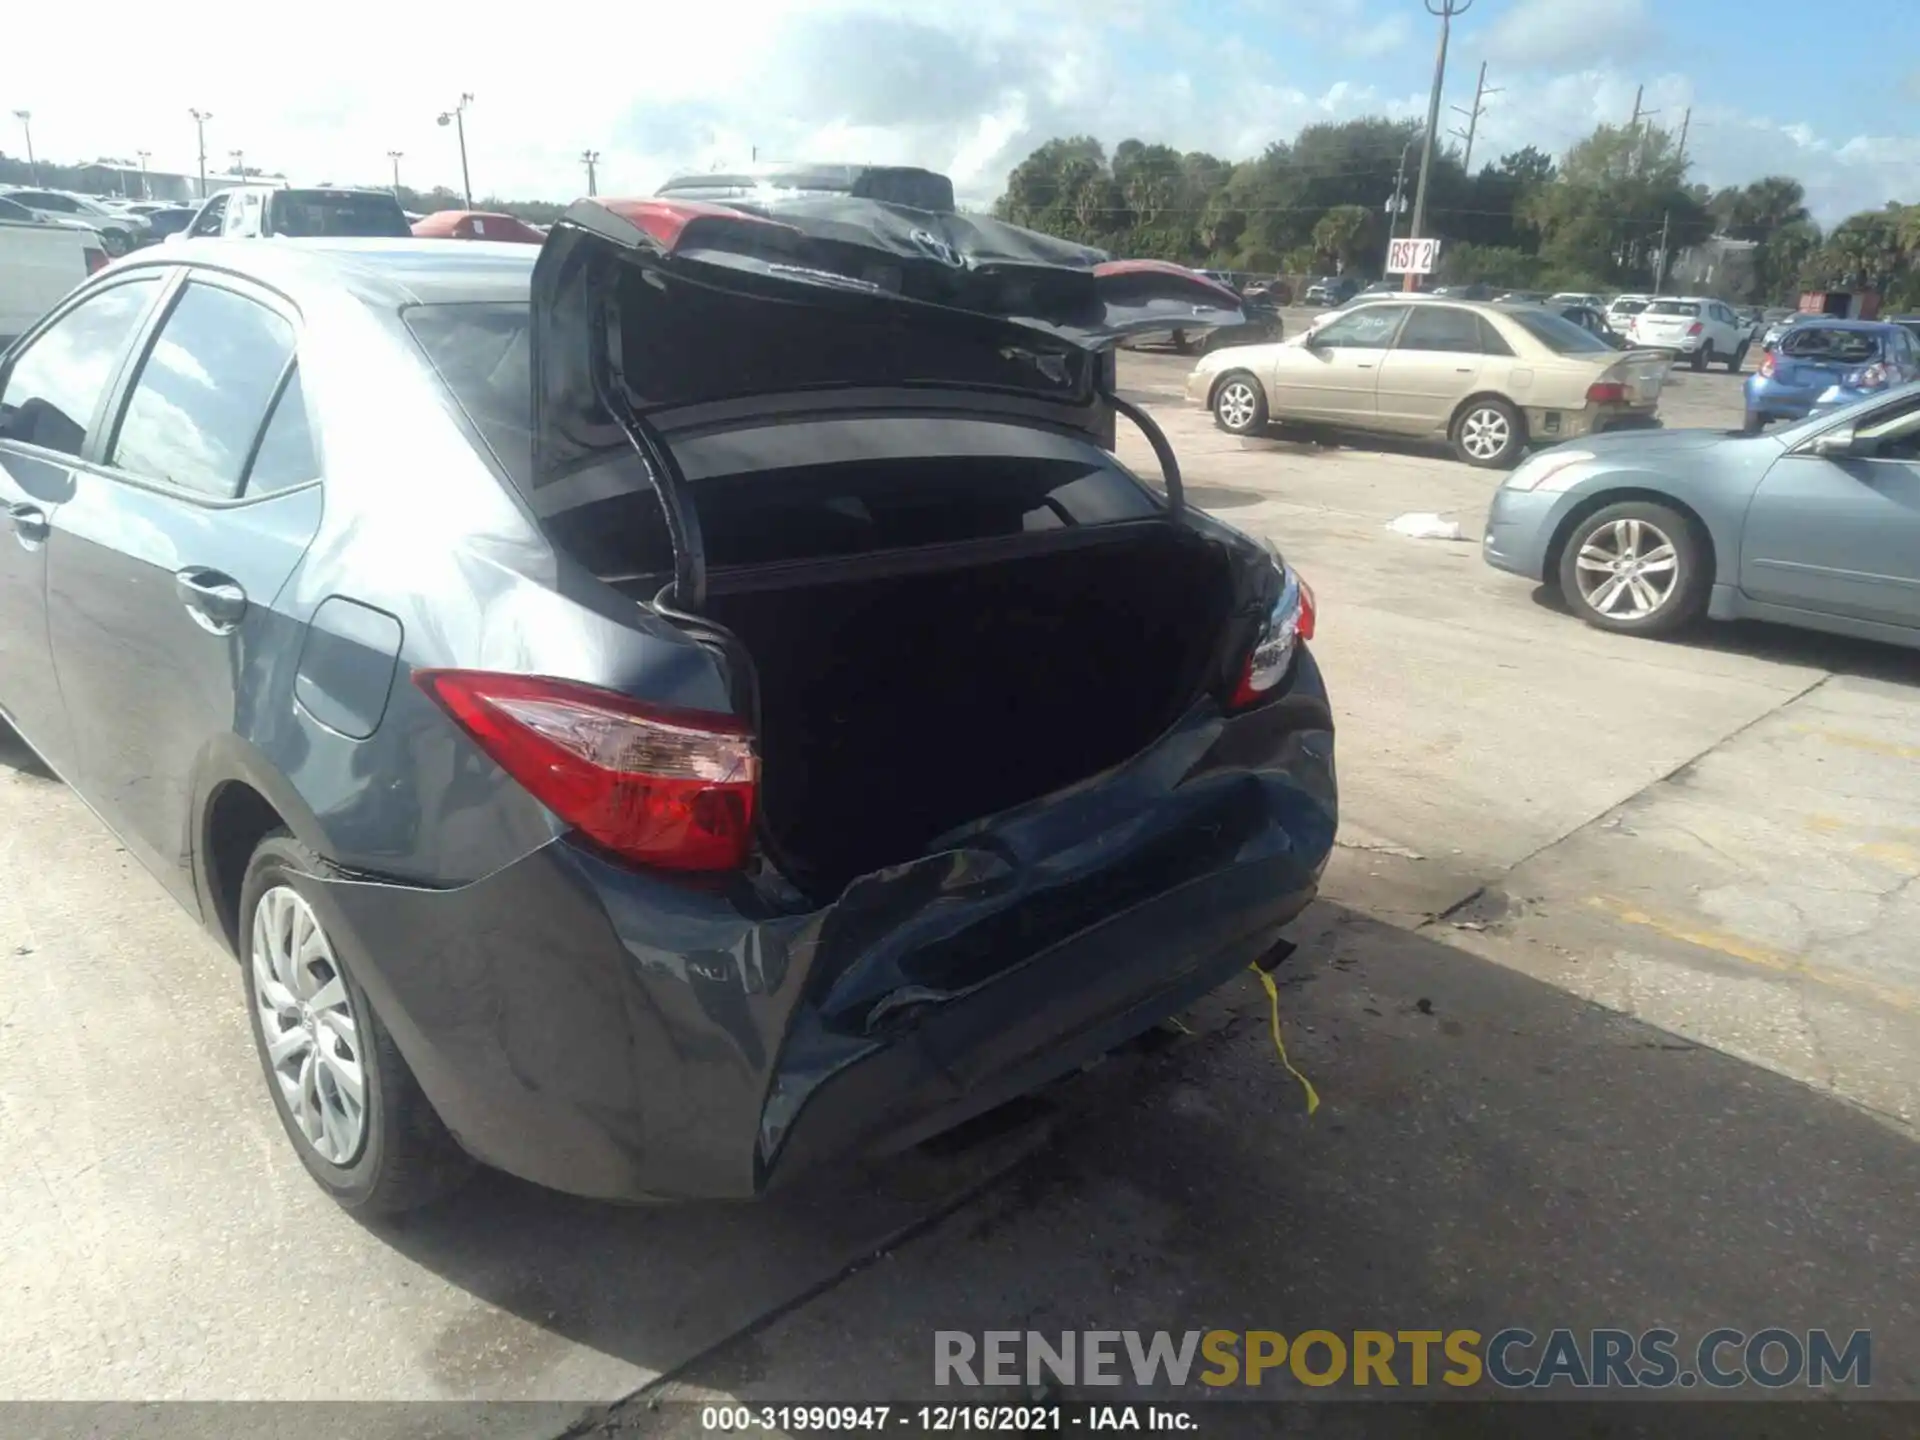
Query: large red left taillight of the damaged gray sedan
[[413, 670, 760, 870]]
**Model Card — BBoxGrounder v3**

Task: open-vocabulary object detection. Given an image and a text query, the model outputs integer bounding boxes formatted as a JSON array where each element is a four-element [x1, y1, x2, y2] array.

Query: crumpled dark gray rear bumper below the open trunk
[[313, 651, 1336, 1200]]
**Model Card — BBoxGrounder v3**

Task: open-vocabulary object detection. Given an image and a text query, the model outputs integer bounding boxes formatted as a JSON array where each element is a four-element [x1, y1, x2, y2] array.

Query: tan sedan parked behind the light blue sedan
[[1187, 296, 1667, 468]]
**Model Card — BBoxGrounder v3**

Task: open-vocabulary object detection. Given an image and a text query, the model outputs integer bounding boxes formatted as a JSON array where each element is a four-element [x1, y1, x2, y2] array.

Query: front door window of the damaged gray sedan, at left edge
[[0, 276, 159, 455]]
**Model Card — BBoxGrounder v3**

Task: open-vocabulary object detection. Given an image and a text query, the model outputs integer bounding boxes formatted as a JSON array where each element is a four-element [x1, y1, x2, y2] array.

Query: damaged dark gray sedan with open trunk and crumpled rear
[[0, 198, 1336, 1212]]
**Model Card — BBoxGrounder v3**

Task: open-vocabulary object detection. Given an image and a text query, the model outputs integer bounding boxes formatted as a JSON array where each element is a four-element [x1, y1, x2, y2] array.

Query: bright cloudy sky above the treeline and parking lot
[[0, 0, 1920, 223]]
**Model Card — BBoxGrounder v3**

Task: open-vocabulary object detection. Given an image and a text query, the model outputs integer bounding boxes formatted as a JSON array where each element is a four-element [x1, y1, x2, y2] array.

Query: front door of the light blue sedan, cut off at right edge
[[1740, 399, 1920, 626]]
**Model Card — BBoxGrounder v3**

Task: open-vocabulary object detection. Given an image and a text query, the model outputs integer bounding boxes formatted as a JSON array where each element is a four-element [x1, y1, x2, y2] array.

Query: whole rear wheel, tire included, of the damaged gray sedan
[[238, 831, 474, 1215]]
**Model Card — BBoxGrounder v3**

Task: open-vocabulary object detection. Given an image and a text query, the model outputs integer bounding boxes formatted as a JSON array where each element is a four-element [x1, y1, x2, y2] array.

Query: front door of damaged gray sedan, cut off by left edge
[[0, 271, 161, 774]]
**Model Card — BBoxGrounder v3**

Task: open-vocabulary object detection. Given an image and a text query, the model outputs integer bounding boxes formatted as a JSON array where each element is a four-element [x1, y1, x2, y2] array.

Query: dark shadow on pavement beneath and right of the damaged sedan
[[362, 904, 1920, 1434]]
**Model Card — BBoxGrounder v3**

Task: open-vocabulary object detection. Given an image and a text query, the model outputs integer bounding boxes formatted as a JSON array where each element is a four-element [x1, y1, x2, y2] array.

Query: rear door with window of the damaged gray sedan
[[48, 271, 321, 906]]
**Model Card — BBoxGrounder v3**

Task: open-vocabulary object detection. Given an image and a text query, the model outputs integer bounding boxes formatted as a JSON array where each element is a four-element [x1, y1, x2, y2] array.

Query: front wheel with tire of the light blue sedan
[[1559, 499, 1711, 636]]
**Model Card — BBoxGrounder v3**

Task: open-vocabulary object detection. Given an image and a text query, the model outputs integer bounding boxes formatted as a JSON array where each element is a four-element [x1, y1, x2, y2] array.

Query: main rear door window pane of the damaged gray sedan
[[109, 284, 294, 499]]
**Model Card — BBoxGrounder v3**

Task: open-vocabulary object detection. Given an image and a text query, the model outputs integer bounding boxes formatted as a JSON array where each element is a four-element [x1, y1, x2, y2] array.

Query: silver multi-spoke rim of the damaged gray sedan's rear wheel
[[252, 885, 367, 1165]]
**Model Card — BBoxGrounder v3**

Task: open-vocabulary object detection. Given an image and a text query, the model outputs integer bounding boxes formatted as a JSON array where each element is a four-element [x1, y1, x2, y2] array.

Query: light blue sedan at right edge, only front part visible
[[1482, 384, 1920, 647]]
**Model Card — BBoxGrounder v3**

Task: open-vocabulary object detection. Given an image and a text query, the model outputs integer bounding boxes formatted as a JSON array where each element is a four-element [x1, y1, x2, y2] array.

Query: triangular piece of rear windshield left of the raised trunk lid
[[399, 301, 534, 486]]
